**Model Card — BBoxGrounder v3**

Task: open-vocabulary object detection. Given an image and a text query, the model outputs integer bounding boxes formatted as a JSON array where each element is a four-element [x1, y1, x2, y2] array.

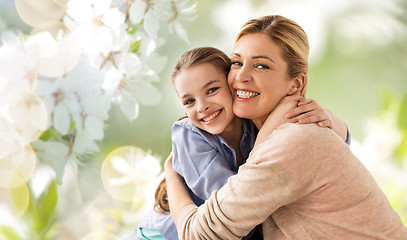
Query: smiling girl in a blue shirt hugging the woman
[[137, 47, 346, 240]]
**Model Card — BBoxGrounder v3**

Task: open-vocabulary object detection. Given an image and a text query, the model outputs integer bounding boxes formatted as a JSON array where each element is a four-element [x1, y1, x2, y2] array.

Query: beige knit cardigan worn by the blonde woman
[[177, 124, 407, 240]]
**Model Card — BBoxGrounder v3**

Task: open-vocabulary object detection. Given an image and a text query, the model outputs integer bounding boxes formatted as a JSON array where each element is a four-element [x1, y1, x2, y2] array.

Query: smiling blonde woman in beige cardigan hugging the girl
[[165, 16, 407, 239]]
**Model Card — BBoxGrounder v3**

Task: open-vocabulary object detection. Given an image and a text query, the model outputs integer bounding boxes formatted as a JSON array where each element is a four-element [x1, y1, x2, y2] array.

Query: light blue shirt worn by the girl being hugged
[[138, 118, 258, 240]]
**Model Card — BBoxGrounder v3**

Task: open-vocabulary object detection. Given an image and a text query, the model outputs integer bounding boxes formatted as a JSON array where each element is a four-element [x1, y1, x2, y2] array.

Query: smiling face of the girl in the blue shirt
[[174, 63, 235, 134]]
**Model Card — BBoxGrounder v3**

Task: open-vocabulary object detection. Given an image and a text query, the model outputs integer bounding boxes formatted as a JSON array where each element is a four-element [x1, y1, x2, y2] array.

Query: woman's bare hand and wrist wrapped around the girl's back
[[164, 152, 194, 224]]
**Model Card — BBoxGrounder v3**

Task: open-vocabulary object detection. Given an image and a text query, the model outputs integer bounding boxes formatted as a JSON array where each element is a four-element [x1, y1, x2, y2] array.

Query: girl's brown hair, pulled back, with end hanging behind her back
[[154, 47, 231, 213]]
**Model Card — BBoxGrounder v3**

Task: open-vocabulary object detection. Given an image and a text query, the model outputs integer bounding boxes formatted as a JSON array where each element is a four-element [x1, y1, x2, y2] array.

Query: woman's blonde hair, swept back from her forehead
[[235, 15, 309, 96]]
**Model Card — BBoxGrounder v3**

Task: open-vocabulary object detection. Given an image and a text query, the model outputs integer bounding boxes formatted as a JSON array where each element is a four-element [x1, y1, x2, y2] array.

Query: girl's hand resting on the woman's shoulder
[[285, 98, 348, 141]]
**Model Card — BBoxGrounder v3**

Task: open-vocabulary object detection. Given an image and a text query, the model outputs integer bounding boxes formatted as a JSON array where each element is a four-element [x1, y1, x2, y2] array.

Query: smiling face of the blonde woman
[[228, 33, 294, 127]]
